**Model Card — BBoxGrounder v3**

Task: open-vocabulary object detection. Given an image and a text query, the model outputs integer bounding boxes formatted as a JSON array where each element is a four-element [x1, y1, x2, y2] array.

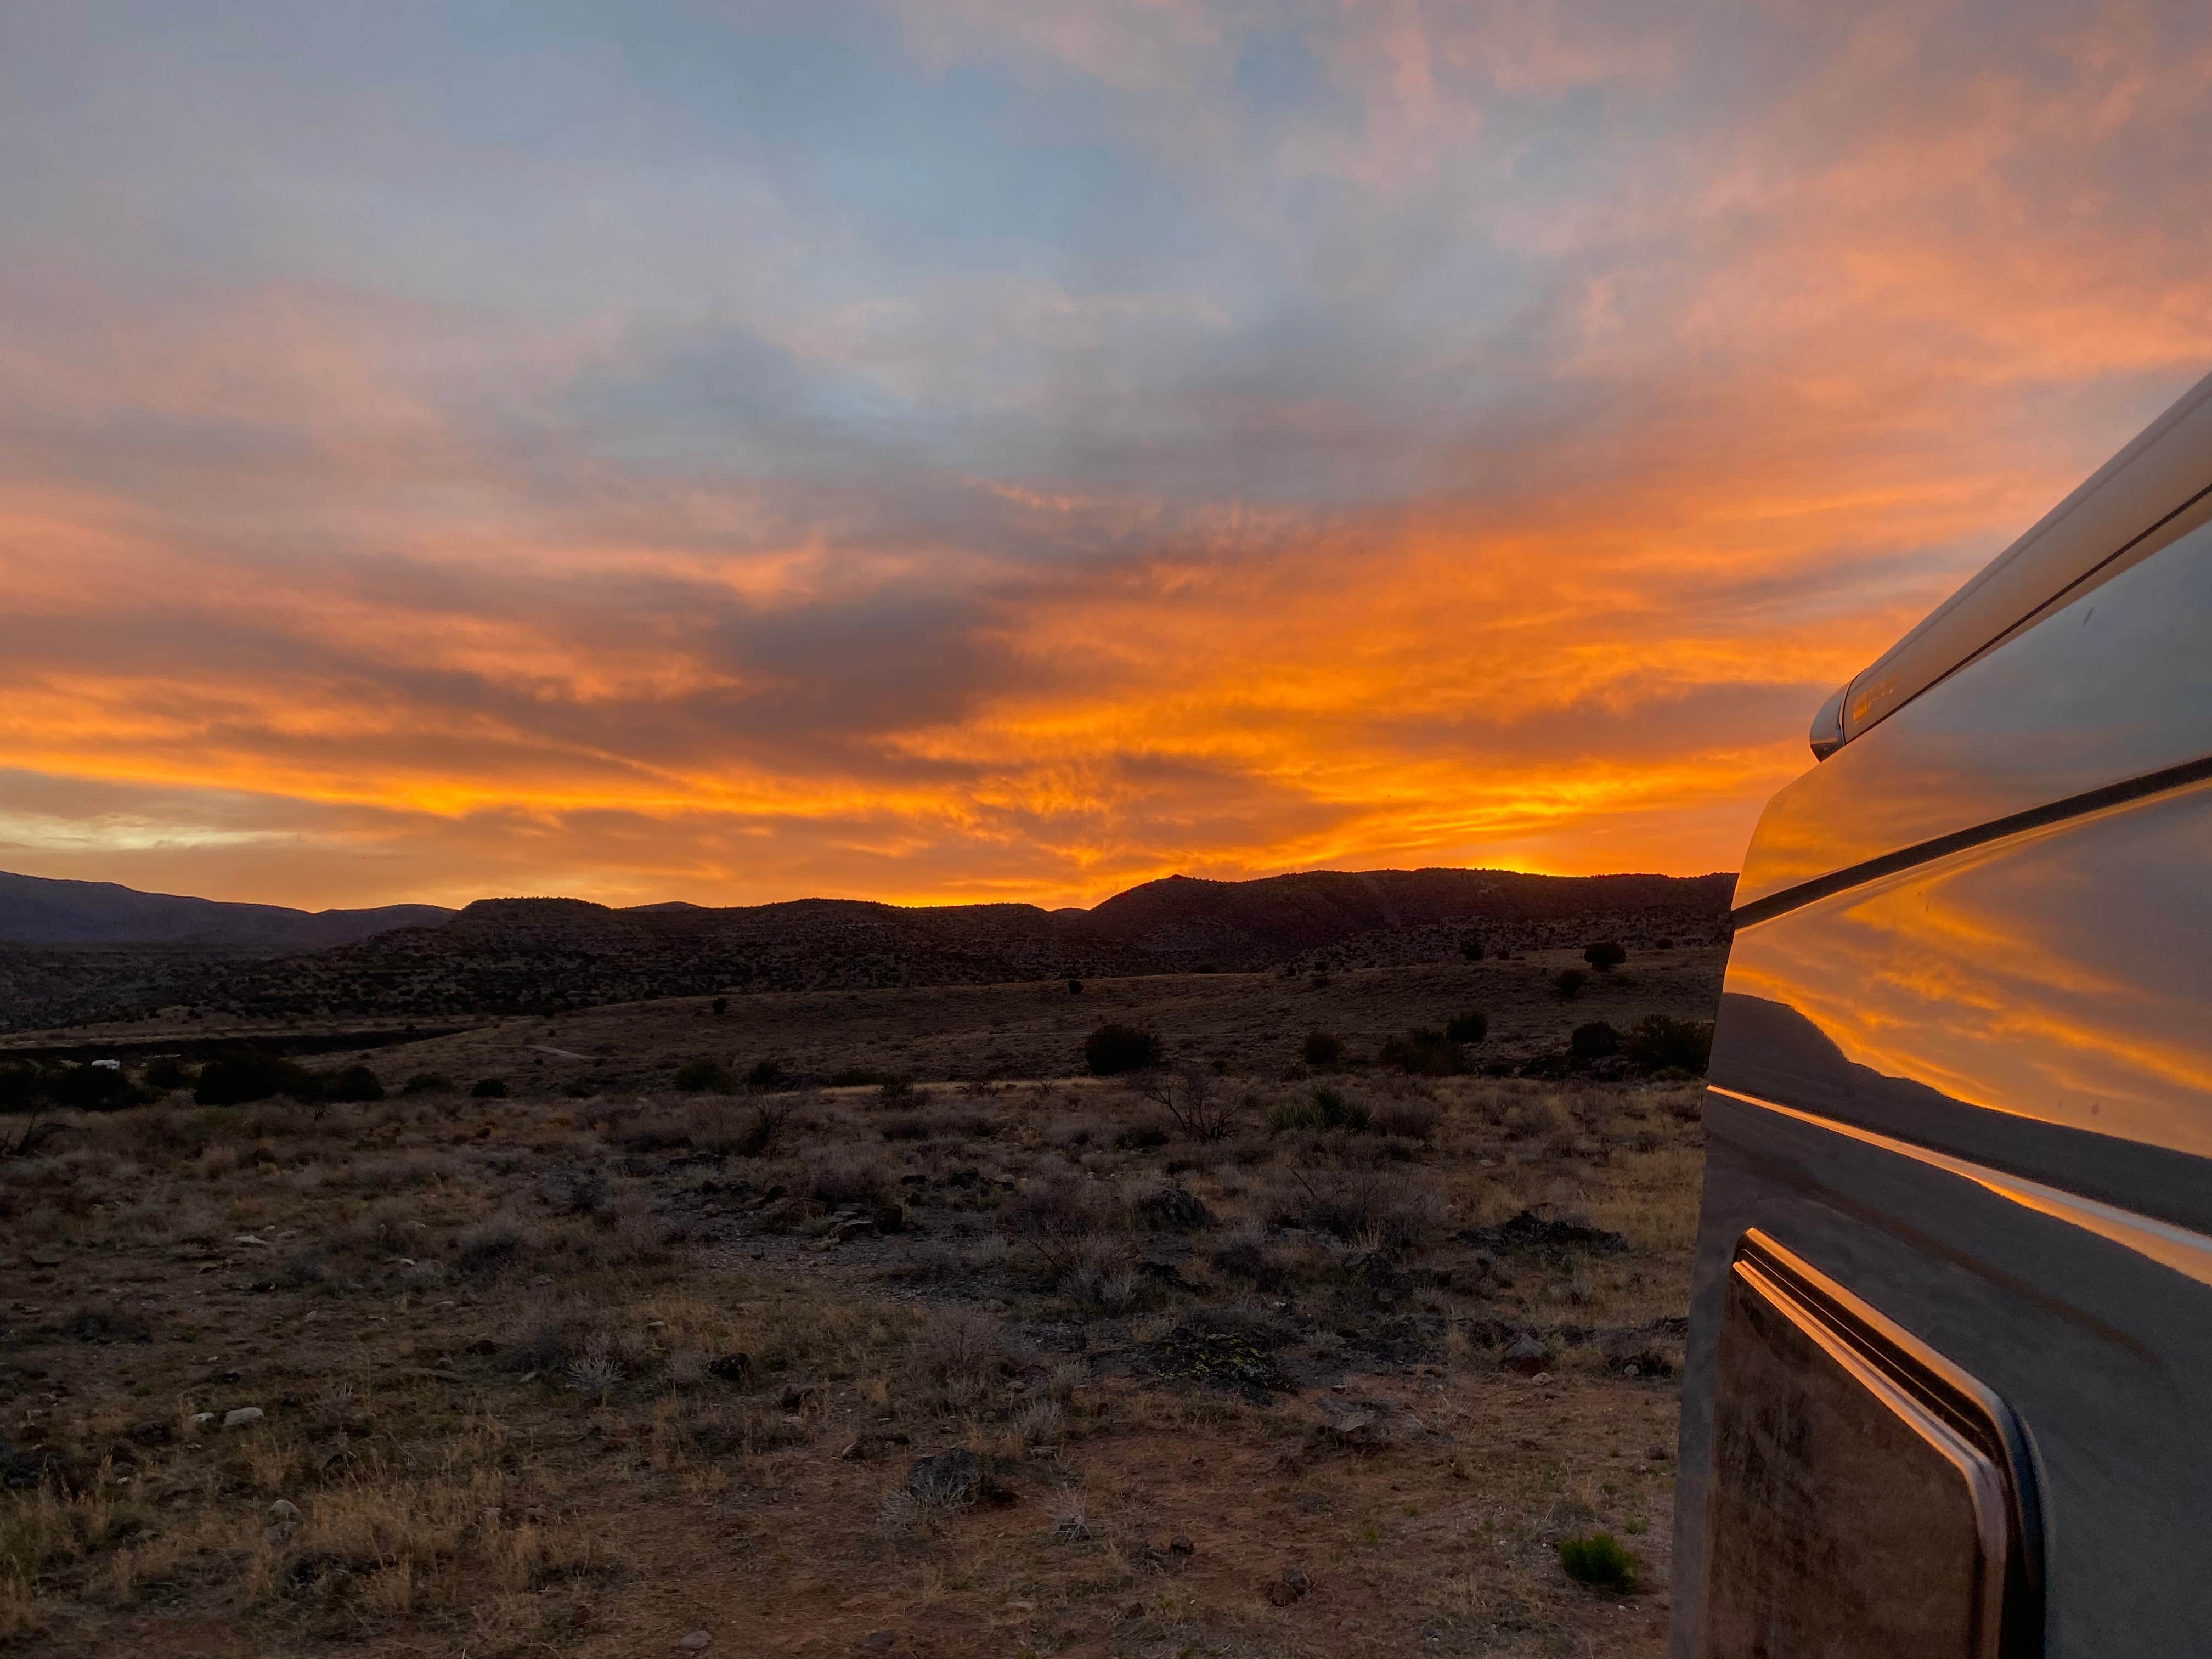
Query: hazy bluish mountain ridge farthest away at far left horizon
[[0, 872, 454, 951]]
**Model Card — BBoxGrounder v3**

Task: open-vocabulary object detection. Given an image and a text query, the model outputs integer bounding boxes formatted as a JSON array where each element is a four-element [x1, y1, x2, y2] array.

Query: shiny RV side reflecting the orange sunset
[[1674, 369, 2212, 1659]]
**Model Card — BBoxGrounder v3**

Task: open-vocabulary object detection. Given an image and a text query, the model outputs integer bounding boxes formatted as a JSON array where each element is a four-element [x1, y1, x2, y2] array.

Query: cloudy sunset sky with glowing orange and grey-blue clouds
[[0, 0, 2212, 907]]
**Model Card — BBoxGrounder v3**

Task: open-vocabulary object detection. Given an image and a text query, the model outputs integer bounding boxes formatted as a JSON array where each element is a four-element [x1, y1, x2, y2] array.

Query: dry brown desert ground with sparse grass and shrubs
[[0, 951, 1717, 1659]]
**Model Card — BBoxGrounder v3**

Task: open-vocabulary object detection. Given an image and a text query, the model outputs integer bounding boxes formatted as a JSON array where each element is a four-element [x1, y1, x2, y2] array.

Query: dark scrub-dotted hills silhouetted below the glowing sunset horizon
[[0, 870, 1734, 1029]]
